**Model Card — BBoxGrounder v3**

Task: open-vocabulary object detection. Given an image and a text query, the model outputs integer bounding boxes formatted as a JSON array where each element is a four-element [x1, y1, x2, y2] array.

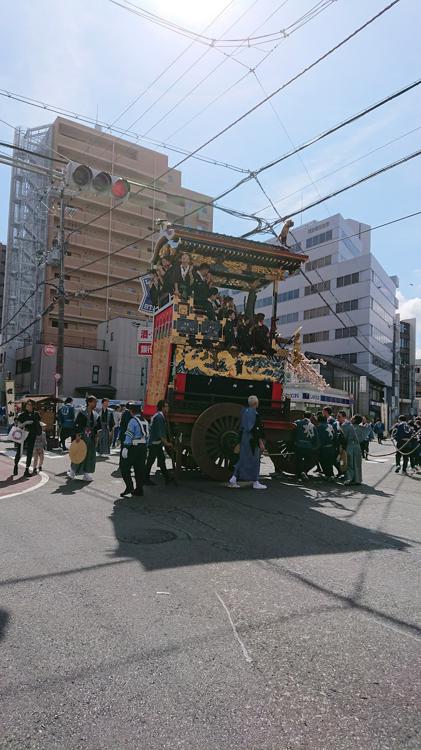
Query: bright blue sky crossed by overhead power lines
[[0, 0, 421, 349]]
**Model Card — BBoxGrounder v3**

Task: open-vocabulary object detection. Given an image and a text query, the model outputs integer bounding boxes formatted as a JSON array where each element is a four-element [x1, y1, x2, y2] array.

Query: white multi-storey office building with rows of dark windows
[[237, 214, 398, 417]]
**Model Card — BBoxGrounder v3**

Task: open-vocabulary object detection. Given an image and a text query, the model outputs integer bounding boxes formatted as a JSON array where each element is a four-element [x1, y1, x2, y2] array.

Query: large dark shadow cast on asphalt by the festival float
[[106, 478, 409, 570]]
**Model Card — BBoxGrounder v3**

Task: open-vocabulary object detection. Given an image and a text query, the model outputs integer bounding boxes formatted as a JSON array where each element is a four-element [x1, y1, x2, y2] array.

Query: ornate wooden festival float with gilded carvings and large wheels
[[144, 225, 326, 481]]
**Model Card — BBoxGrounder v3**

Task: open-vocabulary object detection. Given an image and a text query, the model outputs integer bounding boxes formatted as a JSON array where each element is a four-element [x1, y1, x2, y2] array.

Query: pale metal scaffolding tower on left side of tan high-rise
[[1, 125, 52, 382]]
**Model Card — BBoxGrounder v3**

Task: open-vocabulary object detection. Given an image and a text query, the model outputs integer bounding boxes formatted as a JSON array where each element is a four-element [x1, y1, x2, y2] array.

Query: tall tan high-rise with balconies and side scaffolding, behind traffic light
[[2, 117, 212, 393]]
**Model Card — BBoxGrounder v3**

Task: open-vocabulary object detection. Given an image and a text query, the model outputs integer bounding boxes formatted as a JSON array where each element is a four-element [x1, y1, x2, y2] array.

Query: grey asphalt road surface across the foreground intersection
[[0, 444, 421, 750]]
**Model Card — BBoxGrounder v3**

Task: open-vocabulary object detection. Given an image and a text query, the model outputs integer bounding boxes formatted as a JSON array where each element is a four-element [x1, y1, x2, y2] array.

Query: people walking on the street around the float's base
[[9, 396, 421, 497]]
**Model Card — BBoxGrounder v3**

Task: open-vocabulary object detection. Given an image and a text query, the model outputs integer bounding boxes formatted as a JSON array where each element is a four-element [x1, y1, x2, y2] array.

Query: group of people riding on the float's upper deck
[[150, 253, 271, 354]]
